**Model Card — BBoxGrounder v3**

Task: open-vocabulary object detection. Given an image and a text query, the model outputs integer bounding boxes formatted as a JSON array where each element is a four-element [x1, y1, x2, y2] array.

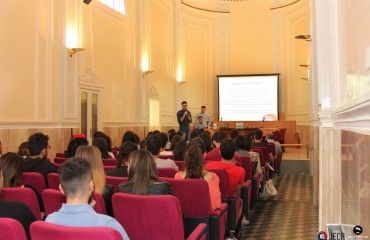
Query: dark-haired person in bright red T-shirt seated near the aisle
[[206, 138, 245, 195]]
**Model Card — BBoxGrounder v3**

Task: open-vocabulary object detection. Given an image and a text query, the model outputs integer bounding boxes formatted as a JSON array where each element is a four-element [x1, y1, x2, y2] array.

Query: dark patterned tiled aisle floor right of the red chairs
[[238, 175, 318, 240]]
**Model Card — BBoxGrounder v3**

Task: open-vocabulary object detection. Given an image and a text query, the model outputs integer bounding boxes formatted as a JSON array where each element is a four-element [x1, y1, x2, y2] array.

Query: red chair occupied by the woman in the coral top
[[161, 178, 227, 240]]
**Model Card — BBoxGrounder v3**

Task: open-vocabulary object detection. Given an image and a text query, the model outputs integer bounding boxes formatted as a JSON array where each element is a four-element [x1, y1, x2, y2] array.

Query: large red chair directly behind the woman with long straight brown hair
[[112, 193, 207, 240]]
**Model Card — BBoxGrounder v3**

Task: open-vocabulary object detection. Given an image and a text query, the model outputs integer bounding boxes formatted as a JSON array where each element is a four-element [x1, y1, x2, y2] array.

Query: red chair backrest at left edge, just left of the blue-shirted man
[[0, 187, 41, 220]]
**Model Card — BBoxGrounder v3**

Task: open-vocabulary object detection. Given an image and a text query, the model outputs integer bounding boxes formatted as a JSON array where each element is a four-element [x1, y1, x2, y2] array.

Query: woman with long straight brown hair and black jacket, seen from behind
[[118, 149, 172, 195]]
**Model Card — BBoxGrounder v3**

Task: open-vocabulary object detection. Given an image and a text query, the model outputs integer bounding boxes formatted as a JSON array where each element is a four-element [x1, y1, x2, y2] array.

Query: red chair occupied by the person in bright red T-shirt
[[208, 168, 241, 237]]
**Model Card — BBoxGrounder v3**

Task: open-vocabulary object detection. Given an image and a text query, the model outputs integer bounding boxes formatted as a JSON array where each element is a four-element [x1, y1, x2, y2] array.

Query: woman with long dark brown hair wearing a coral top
[[174, 142, 221, 211]]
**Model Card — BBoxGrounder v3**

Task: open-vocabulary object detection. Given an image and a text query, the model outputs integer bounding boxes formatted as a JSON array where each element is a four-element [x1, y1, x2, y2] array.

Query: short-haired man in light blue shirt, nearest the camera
[[45, 157, 129, 240]]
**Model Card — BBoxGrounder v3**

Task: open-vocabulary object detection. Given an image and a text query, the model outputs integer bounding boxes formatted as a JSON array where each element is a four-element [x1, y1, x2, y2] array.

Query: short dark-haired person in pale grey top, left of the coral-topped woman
[[145, 135, 179, 171]]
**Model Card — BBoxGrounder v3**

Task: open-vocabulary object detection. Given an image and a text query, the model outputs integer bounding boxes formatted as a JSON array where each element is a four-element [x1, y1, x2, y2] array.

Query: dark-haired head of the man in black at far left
[[28, 132, 50, 158]]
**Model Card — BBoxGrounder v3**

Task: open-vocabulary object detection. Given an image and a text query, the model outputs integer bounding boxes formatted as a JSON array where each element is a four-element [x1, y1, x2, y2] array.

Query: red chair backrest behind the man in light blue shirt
[[31, 221, 122, 240]]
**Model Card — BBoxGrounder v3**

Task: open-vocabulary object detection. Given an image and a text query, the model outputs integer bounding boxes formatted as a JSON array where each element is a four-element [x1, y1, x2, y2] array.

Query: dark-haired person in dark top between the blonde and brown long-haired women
[[106, 141, 138, 177]]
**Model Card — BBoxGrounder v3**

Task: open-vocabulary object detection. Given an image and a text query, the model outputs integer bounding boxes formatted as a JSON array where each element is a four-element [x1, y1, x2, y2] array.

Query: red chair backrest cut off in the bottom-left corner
[[0, 218, 27, 240]]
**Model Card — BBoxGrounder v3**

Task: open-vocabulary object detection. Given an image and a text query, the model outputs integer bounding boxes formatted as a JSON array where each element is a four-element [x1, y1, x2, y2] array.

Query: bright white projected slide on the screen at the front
[[218, 74, 279, 121]]
